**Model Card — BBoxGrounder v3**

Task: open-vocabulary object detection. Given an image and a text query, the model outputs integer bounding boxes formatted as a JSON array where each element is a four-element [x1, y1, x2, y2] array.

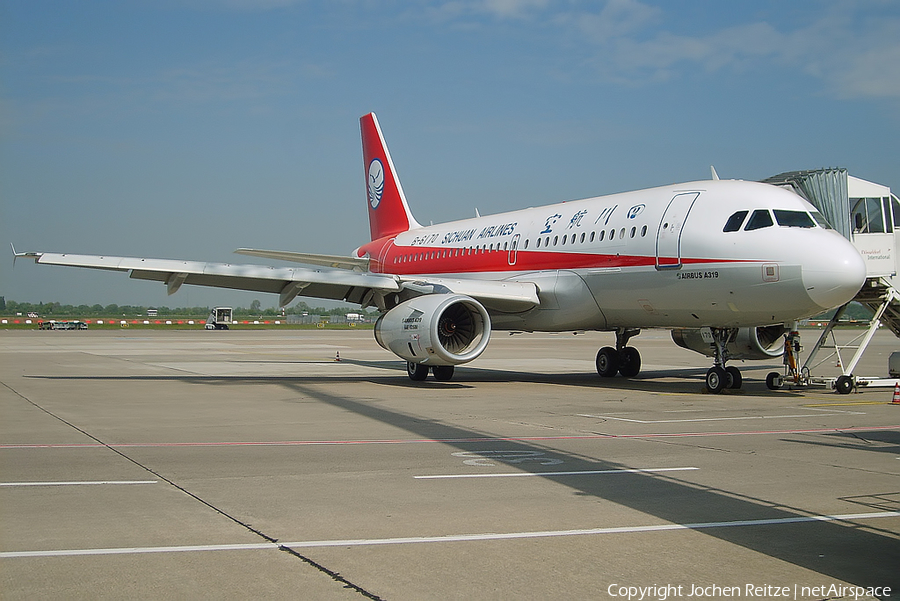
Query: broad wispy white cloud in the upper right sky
[[440, 0, 900, 99]]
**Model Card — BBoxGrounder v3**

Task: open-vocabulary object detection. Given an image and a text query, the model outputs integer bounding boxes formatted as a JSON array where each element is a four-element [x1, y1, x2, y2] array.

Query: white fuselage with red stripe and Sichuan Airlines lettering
[[358, 180, 865, 331]]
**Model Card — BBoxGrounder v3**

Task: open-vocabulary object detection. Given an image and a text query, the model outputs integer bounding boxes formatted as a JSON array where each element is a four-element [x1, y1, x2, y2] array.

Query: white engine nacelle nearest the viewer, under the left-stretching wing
[[375, 294, 491, 365]]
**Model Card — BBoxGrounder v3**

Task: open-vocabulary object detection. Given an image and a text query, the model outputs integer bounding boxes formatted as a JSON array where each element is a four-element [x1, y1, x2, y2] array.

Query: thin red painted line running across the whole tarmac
[[0, 425, 900, 449]]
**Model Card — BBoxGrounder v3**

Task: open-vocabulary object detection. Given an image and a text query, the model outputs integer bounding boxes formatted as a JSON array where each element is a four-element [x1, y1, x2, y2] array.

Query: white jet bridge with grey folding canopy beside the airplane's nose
[[763, 169, 900, 394]]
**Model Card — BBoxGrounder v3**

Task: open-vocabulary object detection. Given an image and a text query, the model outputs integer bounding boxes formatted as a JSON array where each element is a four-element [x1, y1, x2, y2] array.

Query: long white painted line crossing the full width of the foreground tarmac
[[0, 511, 900, 559]]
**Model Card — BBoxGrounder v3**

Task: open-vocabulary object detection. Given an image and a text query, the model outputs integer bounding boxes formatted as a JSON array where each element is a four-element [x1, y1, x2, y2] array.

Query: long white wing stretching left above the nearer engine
[[13, 250, 540, 312]]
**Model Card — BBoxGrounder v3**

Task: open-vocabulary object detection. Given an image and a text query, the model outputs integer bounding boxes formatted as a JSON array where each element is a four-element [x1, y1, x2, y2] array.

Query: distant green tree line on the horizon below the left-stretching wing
[[0, 296, 377, 318]]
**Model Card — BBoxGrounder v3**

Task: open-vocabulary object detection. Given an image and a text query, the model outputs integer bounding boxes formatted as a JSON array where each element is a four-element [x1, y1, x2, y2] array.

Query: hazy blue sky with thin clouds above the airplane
[[0, 0, 900, 307]]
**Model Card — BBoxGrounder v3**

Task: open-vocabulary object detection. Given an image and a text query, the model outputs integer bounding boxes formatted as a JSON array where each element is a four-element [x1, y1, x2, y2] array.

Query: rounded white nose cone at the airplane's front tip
[[803, 232, 866, 311]]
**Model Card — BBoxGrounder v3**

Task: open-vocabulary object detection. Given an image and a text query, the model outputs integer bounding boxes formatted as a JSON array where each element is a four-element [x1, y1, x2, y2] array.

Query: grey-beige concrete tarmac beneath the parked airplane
[[0, 328, 900, 600]]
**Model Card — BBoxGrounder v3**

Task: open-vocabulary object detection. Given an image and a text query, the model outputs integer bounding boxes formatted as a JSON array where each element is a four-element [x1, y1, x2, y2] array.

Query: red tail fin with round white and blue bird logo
[[359, 113, 421, 240]]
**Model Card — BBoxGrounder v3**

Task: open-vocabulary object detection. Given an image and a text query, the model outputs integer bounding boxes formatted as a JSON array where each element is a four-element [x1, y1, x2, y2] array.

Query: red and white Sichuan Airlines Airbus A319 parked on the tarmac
[[13, 113, 866, 393]]
